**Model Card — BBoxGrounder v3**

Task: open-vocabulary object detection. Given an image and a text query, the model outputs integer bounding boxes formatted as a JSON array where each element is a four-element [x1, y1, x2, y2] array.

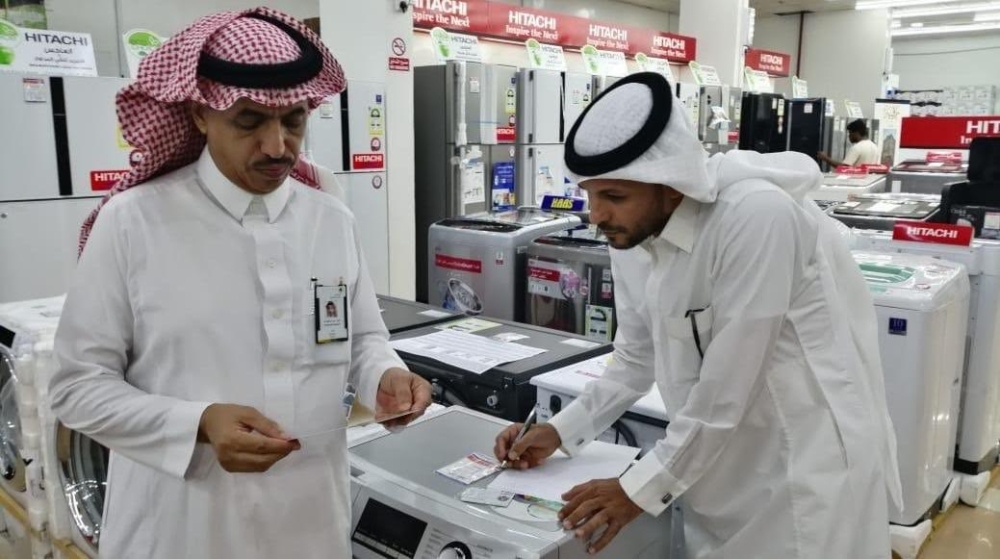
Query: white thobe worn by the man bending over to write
[[551, 161, 898, 559]]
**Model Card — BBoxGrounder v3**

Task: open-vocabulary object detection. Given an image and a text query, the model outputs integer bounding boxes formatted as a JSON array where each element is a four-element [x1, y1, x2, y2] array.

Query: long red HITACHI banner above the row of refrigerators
[[413, 0, 697, 63]]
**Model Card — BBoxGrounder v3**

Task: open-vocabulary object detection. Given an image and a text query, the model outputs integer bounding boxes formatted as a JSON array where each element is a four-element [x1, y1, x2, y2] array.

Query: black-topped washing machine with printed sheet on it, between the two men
[[390, 317, 612, 421]]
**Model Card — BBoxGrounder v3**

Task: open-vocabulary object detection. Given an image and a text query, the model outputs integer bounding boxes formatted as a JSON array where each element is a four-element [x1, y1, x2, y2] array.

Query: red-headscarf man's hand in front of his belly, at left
[[198, 404, 301, 473]]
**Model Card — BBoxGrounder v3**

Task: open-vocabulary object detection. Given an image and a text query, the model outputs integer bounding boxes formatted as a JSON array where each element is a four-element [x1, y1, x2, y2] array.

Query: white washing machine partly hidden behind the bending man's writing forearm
[[531, 353, 669, 455]]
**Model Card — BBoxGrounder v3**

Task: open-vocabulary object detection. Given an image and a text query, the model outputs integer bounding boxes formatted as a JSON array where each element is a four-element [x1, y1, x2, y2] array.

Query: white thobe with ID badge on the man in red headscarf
[[50, 151, 403, 559]]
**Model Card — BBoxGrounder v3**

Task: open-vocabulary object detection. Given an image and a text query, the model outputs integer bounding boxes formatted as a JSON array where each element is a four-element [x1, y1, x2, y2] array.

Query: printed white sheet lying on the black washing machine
[[391, 330, 545, 375]]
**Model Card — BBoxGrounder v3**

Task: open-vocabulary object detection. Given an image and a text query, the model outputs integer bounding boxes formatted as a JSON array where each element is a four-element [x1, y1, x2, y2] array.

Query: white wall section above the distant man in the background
[[799, 10, 889, 116]]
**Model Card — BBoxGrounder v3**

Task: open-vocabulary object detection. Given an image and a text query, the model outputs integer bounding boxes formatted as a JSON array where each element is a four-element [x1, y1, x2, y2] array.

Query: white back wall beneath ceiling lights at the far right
[[892, 33, 1000, 114]]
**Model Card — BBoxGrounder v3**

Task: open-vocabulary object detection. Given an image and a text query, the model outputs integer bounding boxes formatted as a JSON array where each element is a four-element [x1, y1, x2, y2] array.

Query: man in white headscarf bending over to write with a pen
[[495, 73, 900, 559]]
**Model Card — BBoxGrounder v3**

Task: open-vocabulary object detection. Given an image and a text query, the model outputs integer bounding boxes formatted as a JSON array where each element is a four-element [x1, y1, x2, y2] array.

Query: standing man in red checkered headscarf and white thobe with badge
[[50, 8, 430, 559]]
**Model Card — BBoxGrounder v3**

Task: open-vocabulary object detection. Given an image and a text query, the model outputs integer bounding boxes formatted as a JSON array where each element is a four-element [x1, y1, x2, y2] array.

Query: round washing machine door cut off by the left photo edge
[[0, 346, 27, 504]]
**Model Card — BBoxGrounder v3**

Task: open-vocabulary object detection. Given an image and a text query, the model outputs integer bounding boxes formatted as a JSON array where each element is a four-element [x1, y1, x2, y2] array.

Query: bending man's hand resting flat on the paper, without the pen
[[559, 479, 642, 554]]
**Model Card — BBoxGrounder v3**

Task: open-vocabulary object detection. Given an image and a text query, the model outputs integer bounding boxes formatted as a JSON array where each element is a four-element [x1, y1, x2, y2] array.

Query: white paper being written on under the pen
[[489, 441, 639, 501]]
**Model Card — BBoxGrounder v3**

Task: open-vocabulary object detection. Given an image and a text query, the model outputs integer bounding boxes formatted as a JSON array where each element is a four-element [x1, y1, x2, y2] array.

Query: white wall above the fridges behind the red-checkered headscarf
[[45, 0, 318, 76]]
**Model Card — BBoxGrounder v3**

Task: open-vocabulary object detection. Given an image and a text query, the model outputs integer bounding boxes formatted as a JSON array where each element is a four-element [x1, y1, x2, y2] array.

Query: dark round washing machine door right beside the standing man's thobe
[[56, 424, 109, 552]]
